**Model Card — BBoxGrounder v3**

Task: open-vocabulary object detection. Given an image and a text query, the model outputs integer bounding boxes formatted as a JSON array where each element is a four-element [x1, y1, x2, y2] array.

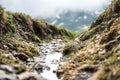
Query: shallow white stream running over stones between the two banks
[[26, 39, 65, 80]]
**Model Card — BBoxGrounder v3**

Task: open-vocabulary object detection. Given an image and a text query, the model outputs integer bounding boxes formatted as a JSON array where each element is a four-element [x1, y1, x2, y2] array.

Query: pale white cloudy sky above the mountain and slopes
[[0, 0, 111, 18]]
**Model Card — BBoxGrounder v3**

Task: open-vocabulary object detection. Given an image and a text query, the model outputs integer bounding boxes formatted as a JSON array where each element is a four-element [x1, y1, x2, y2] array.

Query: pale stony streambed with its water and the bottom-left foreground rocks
[[0, 39, 66, 80]]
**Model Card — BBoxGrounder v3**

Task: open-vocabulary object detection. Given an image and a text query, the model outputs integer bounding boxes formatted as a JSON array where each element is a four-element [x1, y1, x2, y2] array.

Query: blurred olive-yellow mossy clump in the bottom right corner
[[97, 55, 120, 80]]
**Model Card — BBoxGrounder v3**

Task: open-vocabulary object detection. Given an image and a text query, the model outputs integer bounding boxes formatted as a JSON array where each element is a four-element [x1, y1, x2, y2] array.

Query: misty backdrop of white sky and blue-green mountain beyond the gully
[[0, 0, 111, 32]]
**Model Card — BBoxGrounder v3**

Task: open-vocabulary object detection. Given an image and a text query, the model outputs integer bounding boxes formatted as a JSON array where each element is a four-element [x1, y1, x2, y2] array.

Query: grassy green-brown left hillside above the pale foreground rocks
[[0, 6, 76, 63]]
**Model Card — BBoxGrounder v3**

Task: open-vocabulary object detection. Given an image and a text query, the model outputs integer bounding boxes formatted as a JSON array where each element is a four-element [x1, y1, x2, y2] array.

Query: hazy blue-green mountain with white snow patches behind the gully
[[38, 11, 100, 31]]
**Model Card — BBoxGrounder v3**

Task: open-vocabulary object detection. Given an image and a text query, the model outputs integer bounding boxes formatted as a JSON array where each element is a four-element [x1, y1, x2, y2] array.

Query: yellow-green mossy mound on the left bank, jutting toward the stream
[[8, 39, 40, 57]]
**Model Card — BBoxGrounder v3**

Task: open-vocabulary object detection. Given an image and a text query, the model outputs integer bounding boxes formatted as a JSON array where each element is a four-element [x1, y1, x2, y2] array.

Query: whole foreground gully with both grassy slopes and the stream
[[0, 0, 120, 80]]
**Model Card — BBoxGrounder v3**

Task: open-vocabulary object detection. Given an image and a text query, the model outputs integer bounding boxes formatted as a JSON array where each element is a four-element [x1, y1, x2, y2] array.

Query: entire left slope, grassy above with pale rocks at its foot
[[0, 6, 75, 80]]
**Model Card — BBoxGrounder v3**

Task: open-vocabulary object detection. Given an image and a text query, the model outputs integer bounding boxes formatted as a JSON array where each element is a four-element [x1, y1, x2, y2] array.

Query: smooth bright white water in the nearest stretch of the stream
[[41, 53, 62, 80]]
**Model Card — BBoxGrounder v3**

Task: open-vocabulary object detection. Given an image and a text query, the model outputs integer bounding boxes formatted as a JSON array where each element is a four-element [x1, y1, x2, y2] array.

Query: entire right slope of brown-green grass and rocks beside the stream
[[56, 0, 120, 80]]
